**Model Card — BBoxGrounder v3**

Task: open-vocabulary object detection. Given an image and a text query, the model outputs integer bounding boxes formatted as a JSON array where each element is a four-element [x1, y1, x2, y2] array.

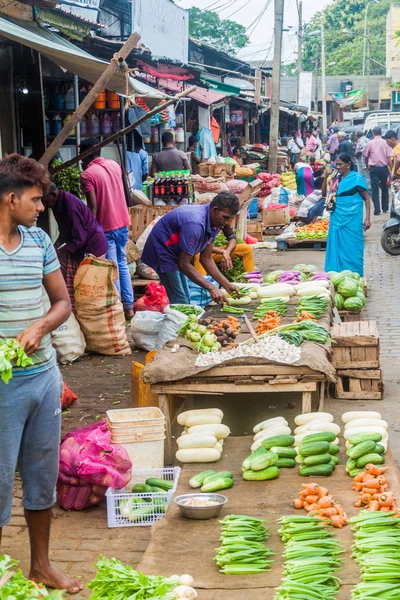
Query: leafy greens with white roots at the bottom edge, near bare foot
[[88, 556, 197, 600]]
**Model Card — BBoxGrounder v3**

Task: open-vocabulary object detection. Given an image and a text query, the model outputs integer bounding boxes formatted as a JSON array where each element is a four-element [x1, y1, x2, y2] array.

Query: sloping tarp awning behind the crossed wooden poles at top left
[[0, 17, 169, 104]]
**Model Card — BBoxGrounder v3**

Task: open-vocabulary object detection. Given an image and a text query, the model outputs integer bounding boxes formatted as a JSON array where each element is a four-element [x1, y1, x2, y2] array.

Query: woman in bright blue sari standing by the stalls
[[322, 154, 371, 276]]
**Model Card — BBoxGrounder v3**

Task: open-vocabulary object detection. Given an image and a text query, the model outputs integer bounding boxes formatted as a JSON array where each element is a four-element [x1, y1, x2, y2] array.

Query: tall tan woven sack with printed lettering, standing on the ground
[[74, 255, 131, 356]]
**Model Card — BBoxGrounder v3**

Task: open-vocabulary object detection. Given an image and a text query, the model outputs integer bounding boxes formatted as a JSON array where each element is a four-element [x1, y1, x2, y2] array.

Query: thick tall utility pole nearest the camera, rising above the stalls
[[268, 0, 284, 173]]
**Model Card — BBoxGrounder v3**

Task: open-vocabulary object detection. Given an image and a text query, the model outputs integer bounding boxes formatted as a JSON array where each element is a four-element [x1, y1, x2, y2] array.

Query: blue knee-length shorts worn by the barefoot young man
[[0, 367, 62, 527]]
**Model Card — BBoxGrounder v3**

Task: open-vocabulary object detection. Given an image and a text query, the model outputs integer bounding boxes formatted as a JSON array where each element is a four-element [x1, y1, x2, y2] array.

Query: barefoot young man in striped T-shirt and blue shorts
[[0, 154, 82, 594]]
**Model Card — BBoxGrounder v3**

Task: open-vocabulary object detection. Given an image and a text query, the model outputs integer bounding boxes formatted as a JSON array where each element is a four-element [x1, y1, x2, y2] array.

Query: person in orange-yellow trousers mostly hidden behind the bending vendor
[[194, 229, 255, 275]]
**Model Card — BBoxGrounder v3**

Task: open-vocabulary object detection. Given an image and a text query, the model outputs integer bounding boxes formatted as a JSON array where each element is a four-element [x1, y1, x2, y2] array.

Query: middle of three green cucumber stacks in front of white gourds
[[297, 431, 339, 477]]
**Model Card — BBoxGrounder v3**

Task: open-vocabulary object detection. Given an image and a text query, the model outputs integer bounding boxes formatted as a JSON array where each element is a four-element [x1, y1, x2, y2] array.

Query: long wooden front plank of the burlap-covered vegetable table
[[151, 380, 317, 394]]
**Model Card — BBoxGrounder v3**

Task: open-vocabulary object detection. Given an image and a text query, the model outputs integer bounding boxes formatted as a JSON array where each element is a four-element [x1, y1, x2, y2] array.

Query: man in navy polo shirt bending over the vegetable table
[[142, 192, 240, 304]]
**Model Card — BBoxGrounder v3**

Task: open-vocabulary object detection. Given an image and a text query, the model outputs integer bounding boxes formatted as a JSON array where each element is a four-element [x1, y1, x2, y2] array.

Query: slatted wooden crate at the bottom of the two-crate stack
[[335, 369, 383, 400]]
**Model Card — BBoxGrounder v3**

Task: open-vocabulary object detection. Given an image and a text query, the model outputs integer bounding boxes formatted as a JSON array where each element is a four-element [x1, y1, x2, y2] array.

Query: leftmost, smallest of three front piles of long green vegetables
[[214, 515, 273, 575]]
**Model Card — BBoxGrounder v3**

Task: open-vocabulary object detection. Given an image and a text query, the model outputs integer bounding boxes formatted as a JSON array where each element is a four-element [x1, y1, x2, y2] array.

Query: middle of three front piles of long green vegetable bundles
[[275, 516, 343, 600]]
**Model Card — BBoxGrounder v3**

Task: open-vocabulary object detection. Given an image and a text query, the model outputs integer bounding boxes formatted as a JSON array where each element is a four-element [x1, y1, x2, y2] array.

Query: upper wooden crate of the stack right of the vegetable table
[[331, 321, 380, 369]]
